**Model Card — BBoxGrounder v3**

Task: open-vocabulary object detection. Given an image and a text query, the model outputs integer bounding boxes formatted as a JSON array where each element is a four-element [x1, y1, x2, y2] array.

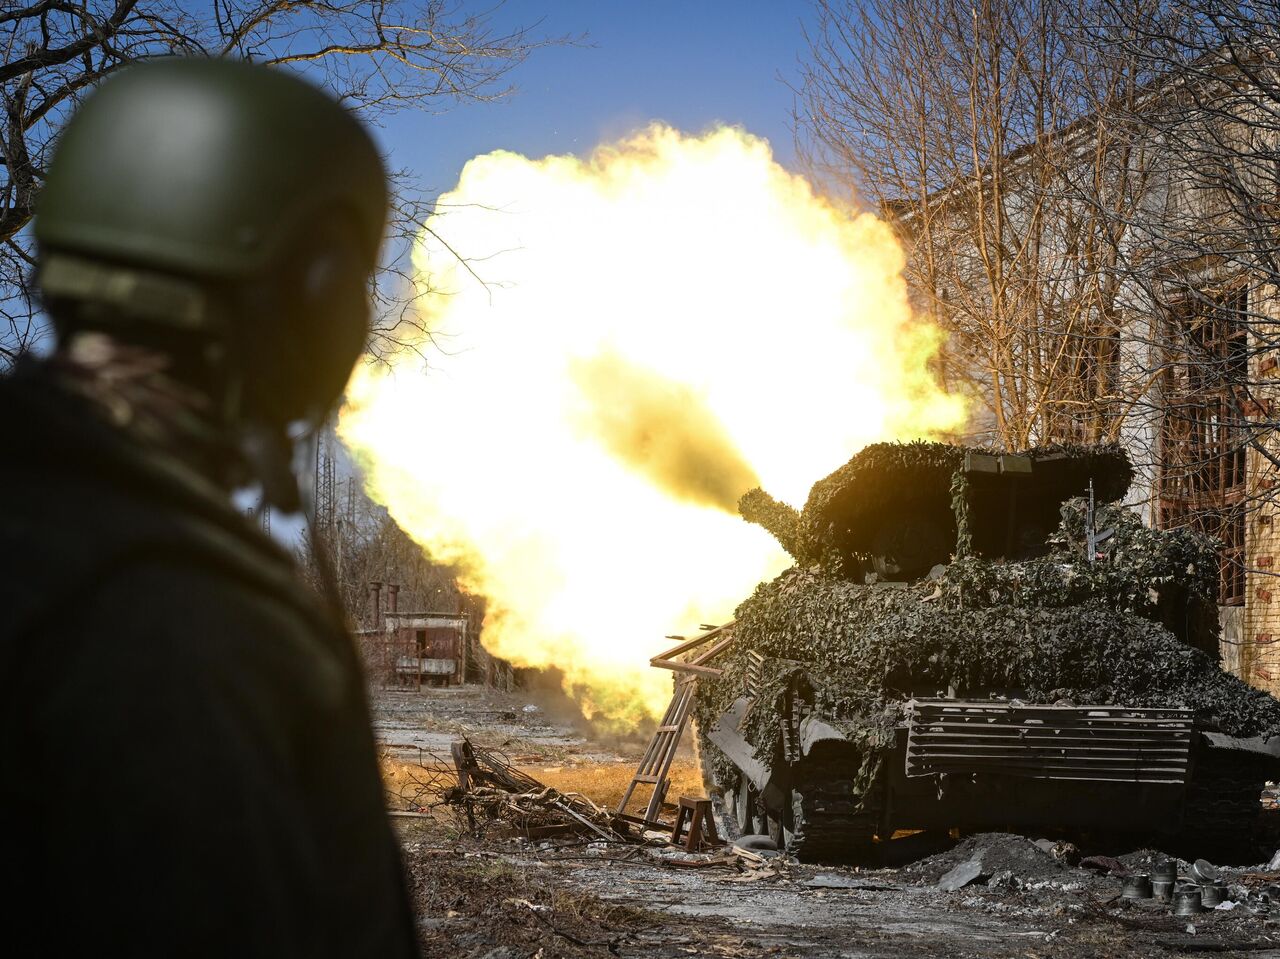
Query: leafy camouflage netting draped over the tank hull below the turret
[[698, 501, 1280, 785]]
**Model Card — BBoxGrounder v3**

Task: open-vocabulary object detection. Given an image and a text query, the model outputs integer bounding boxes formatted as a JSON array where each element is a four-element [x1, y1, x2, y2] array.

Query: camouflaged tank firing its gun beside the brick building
[[694, 443, 1280, 862]]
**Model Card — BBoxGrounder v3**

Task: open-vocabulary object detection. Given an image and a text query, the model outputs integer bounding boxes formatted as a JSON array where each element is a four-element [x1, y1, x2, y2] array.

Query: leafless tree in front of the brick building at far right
[[1085, 0, 1280, 670]]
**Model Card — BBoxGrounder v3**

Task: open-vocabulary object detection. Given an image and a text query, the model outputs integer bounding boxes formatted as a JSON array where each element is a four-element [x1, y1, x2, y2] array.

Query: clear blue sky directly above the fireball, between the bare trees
[[378, 0, 810, 193]]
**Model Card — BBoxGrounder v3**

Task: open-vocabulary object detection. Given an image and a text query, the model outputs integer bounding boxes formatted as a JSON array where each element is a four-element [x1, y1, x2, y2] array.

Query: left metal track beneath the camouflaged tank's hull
[[787, 754, 884, 862]]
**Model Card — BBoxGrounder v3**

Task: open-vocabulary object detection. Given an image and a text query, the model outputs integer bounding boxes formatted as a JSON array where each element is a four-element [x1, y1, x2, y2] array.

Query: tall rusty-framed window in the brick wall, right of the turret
[[1156, 286, 1249, 606]]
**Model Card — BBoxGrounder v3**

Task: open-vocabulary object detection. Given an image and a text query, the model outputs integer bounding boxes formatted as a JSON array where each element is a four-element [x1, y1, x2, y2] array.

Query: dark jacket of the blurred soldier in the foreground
[[0, 373, 415, 956]]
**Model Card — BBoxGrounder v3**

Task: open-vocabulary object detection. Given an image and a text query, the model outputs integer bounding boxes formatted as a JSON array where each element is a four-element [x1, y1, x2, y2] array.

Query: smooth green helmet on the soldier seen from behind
[[35, 58, 388, 423]]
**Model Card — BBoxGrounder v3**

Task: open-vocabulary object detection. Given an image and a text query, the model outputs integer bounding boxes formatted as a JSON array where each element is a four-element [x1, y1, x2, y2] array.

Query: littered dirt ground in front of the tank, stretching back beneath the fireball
[[374, 688, 1280, 959]]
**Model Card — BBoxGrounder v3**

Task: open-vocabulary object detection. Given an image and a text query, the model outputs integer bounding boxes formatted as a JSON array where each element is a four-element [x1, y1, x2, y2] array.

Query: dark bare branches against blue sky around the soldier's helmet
[[0, 0, 559, 367]]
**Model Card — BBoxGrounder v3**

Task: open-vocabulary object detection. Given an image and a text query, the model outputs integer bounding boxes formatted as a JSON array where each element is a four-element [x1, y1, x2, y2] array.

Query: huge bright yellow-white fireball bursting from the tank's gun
[[338, 124, 964, 729]]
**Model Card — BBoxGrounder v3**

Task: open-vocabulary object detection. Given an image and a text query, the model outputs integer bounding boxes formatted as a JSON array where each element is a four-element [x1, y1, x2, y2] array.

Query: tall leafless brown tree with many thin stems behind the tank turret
[[796, 0, 1149, 448]]
